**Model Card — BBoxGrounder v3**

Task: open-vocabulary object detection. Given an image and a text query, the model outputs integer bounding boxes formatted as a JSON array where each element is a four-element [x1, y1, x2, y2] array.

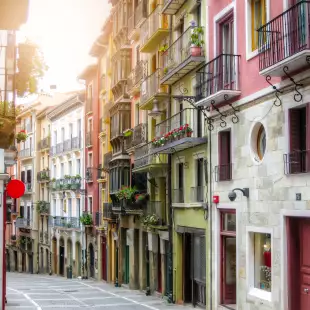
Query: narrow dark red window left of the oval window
[[216, 130, 231, 181]]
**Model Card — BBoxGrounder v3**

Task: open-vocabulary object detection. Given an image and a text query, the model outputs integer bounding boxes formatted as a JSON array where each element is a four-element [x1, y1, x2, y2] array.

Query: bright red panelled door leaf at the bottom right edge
[[299, 220, 310, 310]]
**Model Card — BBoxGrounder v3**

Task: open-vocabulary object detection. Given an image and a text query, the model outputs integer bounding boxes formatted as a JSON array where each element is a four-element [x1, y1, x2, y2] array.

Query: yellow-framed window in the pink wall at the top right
[[251, 0, 267, 51]]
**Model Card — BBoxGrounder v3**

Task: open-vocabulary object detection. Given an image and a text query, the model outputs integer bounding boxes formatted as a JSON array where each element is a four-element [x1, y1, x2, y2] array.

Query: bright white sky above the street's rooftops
[[21, 0, 110, 92]]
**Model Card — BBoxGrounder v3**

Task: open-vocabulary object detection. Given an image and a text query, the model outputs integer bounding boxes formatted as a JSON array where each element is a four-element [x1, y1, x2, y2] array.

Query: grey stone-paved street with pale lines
[[6, 272, 193, 310]]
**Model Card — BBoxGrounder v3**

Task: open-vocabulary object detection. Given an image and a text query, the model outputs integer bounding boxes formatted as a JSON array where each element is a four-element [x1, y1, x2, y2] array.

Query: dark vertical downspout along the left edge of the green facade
[[166, 16, 175, 303]]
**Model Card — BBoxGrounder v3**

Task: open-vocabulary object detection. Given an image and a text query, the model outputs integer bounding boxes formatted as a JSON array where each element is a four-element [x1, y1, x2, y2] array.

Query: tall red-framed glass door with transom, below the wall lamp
[[220, 210, 237, 305]]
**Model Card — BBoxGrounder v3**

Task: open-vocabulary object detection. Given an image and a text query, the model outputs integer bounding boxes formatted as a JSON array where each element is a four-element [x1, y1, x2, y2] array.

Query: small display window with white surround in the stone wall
[[254, 233, 271, 292]]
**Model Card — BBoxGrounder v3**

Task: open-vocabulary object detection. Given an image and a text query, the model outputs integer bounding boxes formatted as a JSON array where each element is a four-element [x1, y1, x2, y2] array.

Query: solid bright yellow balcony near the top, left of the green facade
[[140, 5, 170, 53]]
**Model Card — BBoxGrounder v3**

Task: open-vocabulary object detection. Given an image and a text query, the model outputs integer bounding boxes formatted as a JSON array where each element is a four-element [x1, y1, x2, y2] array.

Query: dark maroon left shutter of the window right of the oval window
[[285, 109, 301, 173]]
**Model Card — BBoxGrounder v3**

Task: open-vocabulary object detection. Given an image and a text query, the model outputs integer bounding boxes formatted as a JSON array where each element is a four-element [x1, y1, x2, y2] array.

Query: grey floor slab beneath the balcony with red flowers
[[151, 137, 208, 154]]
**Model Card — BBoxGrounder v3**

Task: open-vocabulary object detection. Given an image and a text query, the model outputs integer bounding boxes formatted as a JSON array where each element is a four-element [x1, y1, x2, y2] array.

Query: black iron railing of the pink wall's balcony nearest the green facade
[[196, 54, 240, 99]]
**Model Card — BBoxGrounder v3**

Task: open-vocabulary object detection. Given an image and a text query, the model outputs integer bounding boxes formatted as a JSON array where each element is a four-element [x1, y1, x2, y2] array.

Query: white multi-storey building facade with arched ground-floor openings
[[47, 93, 87, 277]]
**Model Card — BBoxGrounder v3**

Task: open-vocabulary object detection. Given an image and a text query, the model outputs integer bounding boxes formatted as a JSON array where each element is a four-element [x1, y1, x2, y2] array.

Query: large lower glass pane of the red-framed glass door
[[225, 237, 236, 285]]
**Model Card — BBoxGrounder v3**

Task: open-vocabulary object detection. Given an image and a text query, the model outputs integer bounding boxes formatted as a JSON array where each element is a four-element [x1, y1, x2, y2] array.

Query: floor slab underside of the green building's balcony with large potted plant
[[160, 56, 205, 85]]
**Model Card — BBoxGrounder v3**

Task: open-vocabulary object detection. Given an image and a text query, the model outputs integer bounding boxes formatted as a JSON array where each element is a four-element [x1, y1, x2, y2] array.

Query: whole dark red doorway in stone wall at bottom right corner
[[286, 217, 310, 310]]
